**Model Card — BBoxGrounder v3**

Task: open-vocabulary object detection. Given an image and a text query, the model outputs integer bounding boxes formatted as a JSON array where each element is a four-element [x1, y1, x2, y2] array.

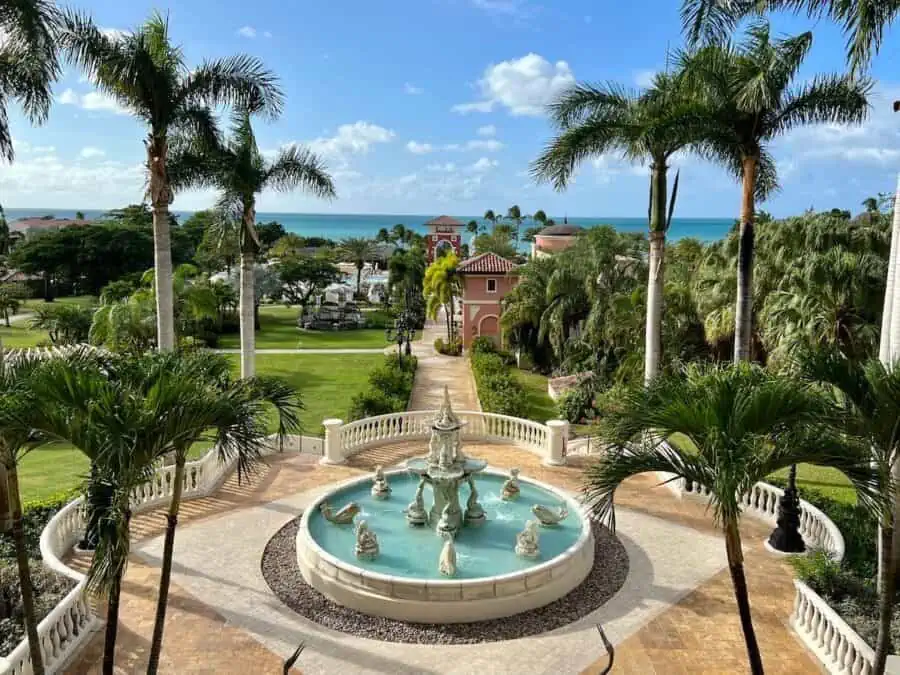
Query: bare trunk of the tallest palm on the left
[[147, 134, 175, 351]]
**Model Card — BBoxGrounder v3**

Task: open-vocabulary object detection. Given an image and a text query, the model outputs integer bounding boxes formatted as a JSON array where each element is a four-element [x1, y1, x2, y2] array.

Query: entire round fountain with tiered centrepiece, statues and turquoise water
[[297, 388, 594, 623]]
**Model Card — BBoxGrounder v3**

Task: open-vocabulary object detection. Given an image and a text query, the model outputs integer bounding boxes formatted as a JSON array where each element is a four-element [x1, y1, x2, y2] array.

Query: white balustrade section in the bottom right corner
[[791, 579, 875, 675]]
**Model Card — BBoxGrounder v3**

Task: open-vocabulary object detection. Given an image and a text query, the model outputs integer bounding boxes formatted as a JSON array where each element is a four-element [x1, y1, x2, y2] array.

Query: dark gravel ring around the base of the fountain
[[260, 516, 628, 645]]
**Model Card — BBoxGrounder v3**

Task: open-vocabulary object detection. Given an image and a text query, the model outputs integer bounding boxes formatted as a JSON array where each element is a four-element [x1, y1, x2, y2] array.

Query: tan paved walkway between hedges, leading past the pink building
[[408, 312, 481, 410]]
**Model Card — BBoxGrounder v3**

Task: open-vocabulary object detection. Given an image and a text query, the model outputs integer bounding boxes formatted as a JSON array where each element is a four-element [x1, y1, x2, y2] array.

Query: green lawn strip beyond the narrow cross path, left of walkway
[[219, 305, 387, 349]]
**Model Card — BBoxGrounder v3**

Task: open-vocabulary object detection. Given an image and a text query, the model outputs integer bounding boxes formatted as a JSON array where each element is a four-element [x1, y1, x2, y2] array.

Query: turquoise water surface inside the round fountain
[[309, 472, 583, 579]]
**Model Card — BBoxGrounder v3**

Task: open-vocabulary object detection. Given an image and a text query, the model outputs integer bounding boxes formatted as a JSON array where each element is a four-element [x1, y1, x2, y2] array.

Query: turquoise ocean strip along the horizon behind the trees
[[6, 209, 734, 246]]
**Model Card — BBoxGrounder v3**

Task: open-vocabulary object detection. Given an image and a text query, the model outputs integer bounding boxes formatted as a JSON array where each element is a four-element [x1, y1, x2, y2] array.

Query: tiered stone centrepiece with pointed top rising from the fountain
[[406, 387, 487, 537]]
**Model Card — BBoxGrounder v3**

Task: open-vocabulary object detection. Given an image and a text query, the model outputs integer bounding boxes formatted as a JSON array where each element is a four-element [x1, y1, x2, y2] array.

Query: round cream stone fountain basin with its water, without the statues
[[297, 469, 594, 623]]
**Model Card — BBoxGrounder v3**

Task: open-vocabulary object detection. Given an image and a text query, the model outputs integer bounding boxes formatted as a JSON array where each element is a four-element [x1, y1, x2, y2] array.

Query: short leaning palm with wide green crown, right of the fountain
[[583, 364, 879, 675]]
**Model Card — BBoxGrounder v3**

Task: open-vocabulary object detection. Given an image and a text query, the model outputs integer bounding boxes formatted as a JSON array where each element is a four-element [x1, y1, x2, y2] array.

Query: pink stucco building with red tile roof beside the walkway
[[457, 253, 519, 349]]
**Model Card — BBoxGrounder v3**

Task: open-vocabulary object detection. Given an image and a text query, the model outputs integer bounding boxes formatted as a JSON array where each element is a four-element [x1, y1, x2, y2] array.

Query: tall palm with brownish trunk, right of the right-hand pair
[[678, 22, 872, 361]]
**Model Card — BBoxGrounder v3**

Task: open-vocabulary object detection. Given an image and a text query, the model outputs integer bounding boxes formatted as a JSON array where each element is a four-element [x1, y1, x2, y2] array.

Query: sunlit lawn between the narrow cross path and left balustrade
[[19, 354, 384, 500]]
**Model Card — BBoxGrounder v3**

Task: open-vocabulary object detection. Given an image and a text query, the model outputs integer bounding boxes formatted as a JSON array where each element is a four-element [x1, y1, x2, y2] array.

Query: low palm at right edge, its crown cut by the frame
[[799, 349, 900, 673]]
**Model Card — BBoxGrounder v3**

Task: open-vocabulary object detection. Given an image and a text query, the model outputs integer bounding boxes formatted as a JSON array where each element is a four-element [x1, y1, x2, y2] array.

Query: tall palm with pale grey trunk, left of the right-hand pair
[[532, 73, 699, 381]]
